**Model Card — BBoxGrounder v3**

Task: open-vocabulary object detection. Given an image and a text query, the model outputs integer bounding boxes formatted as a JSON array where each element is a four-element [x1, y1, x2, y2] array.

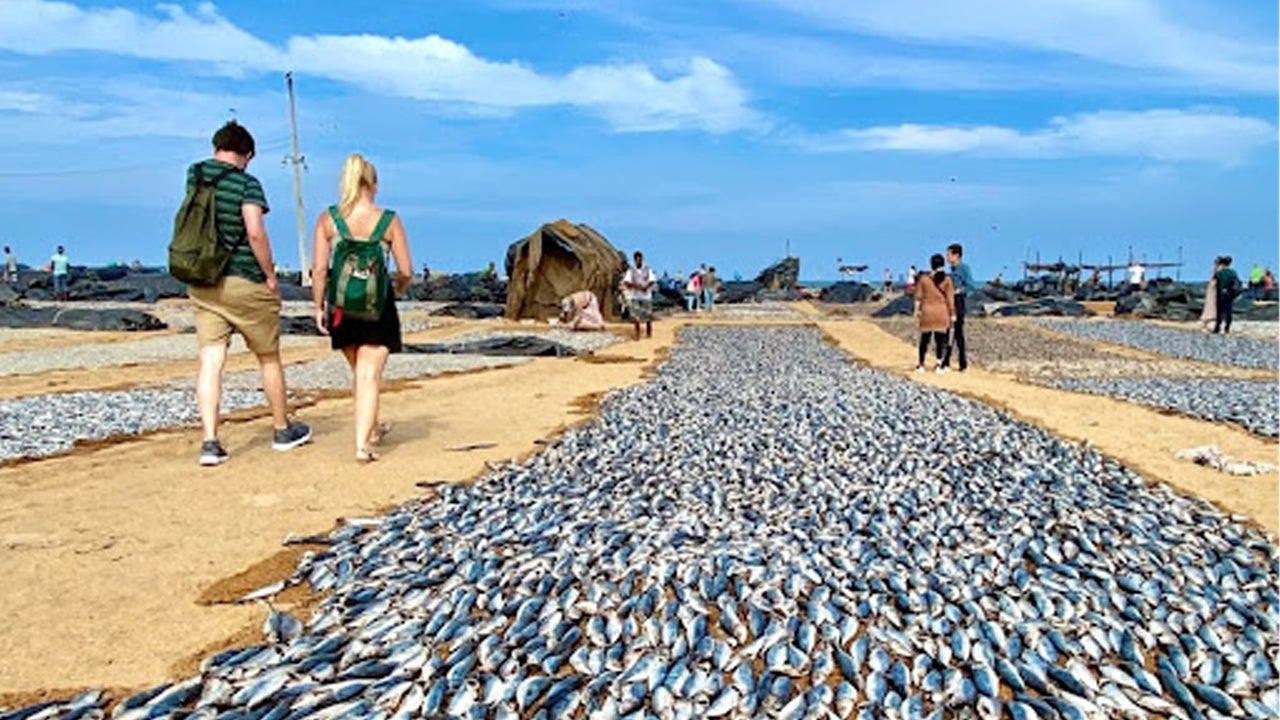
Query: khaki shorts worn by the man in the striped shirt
[[187, 275, 280, 355]]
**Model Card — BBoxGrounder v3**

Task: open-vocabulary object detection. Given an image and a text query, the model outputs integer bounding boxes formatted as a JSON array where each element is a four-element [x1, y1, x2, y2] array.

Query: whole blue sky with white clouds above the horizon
[[0, 0, 1280, 279]]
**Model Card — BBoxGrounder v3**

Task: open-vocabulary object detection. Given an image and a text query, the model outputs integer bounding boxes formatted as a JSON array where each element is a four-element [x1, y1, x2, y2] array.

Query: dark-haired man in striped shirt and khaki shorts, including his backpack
[[176, 120, 311, 466]]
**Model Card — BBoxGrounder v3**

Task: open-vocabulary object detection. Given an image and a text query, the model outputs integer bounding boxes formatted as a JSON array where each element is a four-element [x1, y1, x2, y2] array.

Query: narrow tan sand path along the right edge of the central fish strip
[[820, 320, 1280, 536]]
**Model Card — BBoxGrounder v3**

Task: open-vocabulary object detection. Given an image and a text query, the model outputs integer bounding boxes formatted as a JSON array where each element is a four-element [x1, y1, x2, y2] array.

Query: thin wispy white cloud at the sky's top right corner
[[756, 0, 1276, 94]]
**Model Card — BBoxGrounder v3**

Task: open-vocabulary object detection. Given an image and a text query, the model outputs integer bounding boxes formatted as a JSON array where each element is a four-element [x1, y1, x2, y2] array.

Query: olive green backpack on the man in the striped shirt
[[169, 164, 238, 286]]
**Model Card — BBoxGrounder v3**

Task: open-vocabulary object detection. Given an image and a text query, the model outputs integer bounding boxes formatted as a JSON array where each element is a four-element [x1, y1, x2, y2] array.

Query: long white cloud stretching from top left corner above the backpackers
[[0, 0, 762, 133]]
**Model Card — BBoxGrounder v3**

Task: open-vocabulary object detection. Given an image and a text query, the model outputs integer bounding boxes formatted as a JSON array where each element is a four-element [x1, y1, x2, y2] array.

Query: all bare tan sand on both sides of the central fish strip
[[0, 304, 1277, 706]]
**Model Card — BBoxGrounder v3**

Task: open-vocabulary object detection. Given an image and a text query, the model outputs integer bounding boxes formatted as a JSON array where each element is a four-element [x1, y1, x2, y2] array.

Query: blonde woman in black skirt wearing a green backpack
[[311, 154, 413, 462]]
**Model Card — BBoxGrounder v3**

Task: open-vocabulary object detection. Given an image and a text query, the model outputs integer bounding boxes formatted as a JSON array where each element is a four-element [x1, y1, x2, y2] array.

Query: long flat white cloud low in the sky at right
[[795, 109, 1276, 165]]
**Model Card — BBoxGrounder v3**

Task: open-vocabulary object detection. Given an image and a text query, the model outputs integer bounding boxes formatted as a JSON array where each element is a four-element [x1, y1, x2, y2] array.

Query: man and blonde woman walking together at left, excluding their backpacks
[[187, 120, 413, 465]]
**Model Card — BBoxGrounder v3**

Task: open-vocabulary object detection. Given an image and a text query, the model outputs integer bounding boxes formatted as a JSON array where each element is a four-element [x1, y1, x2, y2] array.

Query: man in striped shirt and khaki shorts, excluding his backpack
[[187, 120, 311, 465]]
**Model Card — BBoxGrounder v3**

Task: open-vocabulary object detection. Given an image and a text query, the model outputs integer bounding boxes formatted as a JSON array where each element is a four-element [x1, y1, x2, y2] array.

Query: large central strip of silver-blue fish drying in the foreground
[[2, 327, 1280, 720]]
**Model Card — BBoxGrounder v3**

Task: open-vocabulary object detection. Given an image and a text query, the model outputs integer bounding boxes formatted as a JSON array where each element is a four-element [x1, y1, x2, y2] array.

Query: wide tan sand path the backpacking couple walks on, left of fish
[[0, 323, 675, 705]]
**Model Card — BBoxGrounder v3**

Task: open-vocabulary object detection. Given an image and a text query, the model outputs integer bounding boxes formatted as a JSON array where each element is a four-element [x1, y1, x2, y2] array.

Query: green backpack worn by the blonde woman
[[326, 205, 396, 324]]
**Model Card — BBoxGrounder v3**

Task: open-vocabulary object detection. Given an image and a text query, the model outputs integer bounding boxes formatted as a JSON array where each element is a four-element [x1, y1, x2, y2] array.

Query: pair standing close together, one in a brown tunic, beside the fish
[[908, 243, 978, 373]]
